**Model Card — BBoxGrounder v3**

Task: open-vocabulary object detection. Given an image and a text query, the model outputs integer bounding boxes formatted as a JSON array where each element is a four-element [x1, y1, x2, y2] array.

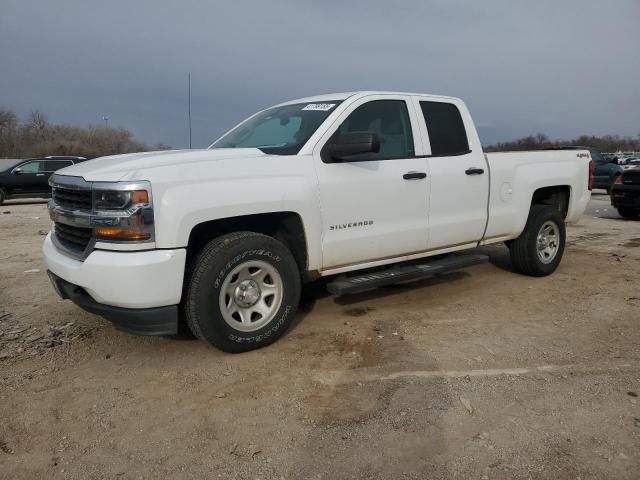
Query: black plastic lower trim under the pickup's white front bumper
[[47, 270, 178, 335]]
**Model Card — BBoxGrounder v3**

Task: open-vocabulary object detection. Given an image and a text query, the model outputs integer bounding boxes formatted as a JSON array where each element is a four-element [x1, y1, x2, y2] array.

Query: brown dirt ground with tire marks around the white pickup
[[0, 194, 640, 480]]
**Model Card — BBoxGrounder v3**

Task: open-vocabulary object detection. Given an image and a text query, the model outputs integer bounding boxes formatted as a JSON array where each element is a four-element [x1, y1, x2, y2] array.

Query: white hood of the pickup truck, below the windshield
[[56, 148, 269, 182]]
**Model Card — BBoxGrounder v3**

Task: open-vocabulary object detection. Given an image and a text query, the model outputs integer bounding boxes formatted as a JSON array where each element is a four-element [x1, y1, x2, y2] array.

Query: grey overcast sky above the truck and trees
[[0, 0, 640, 148]]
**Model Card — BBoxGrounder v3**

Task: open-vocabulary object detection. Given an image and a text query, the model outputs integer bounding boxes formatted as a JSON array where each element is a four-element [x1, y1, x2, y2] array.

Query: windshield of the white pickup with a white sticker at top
[[209, 100, 341, 155]]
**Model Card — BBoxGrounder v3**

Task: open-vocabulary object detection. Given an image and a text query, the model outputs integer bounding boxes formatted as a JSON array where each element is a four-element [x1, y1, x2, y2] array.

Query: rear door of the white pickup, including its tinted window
[[414, 96, 489, 250]]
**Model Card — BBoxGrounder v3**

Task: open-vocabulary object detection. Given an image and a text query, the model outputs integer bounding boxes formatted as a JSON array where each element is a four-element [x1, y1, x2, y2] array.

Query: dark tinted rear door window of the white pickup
[[420, 102, 469, 155]]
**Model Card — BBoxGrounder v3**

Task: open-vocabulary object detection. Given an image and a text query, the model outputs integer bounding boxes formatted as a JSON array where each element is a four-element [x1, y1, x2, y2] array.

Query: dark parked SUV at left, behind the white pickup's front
[[0, 156, 86, 205]]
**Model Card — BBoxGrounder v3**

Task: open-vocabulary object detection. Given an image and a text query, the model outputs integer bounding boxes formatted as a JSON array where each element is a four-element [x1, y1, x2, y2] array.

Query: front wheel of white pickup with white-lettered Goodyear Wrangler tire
[[183, 232, 300, 353]]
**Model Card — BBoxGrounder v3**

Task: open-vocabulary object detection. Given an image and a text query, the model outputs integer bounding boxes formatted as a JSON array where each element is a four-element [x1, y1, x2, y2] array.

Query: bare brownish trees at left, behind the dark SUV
[[0, 108, 170, 158]]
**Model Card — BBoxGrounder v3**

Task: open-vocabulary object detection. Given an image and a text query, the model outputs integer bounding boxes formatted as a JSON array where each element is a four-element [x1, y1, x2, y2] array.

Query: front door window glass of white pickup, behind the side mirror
[[336, 100, 415, 161]]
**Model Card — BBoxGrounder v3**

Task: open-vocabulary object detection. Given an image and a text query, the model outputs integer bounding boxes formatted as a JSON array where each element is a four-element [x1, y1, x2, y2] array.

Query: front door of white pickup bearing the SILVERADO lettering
[[314, 95, 429, 270]]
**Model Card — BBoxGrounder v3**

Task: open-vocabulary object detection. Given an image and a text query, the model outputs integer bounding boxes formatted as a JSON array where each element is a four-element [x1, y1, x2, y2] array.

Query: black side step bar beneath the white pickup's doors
[[327, 254, 489, 295]]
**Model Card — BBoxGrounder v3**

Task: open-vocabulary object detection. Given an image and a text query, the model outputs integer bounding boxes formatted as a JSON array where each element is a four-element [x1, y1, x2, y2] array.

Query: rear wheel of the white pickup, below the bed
[[509, 205, 566, 277]]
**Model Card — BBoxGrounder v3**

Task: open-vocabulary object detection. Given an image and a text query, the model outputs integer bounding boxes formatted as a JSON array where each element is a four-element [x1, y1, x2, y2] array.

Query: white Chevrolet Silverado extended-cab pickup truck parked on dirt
[[43, 92, 593, 352]]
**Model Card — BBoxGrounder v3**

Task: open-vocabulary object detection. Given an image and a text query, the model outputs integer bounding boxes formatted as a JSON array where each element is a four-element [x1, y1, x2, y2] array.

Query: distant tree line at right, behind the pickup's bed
[[484, 133, 640, 153]]
